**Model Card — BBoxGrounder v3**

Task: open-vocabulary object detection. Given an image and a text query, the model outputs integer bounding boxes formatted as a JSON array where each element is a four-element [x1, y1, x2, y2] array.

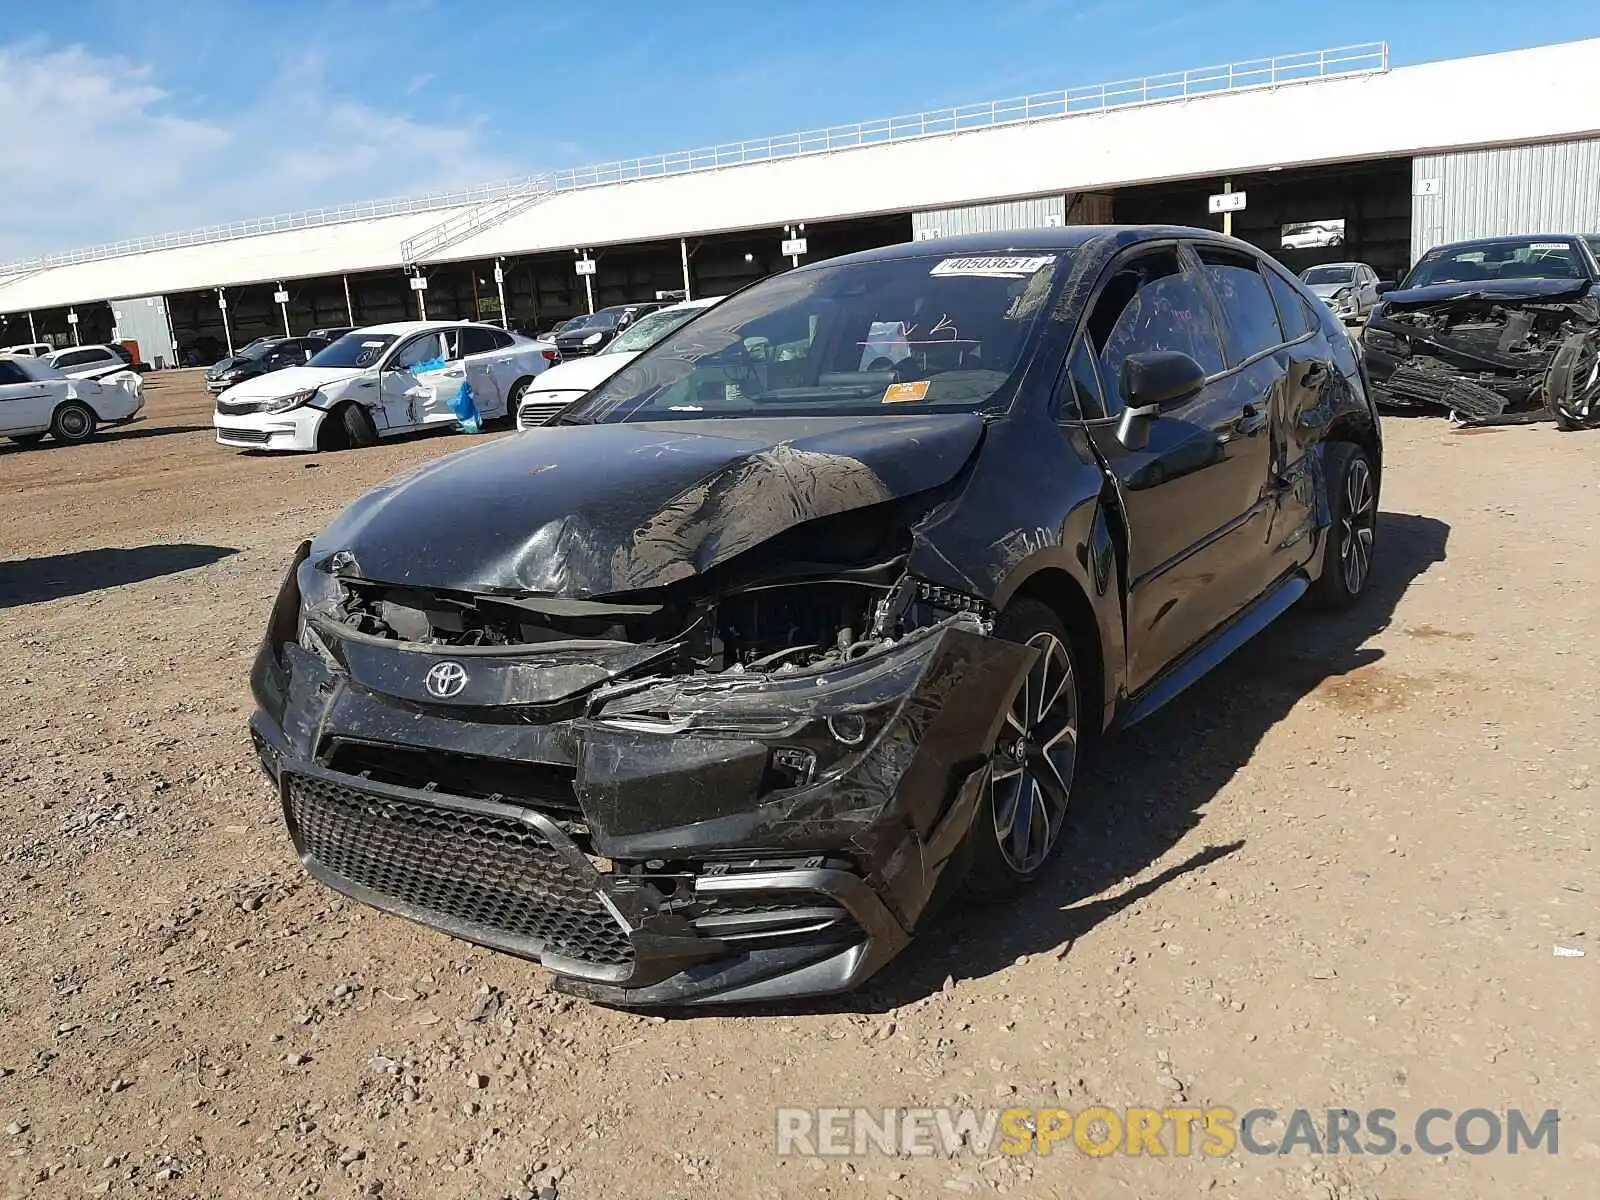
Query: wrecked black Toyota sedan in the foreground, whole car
[[251, 227, 1381, 1006]]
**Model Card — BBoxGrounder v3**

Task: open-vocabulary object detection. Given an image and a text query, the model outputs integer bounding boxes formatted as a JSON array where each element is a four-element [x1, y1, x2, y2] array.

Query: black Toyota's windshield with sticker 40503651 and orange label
[[563, 251, 1067, 424]]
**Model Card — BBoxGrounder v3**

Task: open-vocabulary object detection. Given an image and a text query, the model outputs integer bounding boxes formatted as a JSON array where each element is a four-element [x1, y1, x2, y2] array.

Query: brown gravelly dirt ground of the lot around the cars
[[0, 373, 1600, 1200]]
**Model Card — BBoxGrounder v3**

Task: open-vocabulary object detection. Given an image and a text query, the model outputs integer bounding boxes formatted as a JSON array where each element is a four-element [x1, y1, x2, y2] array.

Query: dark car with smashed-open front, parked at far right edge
[[1362, 235, 1600, 429]]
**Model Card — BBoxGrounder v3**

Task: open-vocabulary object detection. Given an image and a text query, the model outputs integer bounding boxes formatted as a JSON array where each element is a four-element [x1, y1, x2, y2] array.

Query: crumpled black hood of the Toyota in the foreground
[[313, 416, 982, 598]]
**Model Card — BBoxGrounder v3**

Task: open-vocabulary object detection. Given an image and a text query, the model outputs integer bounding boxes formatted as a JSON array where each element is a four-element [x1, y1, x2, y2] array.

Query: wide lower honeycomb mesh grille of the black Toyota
[[286, 776, 634, 966]]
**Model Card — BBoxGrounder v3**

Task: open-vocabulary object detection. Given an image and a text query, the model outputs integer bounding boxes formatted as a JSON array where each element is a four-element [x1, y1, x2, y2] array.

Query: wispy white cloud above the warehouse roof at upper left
[[0, 40, 530, 261]]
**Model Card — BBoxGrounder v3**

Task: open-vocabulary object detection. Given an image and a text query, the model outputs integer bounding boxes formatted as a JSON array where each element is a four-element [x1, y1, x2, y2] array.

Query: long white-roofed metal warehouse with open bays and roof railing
[[0, 40, 1600, 362]]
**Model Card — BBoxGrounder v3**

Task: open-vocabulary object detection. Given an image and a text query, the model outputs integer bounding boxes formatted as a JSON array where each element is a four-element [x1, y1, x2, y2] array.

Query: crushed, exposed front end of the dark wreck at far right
[[1363, 296, 1600, 429]]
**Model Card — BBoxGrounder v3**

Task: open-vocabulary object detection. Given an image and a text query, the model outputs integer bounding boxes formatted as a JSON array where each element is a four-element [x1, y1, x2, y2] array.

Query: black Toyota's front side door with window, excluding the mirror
[[1074, 243, 1266, 690]]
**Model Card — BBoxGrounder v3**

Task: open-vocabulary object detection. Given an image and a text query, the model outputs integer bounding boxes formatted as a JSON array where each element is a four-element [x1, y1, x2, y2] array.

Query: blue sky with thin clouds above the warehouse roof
[[0, 0, 1600, 259]]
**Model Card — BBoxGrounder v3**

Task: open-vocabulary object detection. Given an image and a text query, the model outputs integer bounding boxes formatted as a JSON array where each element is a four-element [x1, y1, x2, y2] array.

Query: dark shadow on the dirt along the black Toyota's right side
[[713, 512, 1450, 1013]]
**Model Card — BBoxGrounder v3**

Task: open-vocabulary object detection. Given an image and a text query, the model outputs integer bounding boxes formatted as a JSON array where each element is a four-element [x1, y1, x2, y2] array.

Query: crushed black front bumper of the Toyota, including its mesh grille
[[251, 622, 1034, 1006]]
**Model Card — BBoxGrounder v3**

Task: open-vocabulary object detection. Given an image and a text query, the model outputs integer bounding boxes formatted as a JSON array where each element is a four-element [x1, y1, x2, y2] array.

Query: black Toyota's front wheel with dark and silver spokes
[[965, 598, 1085, 901]]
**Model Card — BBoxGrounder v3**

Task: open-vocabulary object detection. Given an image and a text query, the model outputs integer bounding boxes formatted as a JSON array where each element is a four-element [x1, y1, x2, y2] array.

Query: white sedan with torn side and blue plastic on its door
[[213, 322, 557, 451]]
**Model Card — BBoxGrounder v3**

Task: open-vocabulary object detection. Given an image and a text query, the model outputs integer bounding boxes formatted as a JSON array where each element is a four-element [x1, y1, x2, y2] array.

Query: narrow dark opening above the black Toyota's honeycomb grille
[[326, 741, 582, 816]]
